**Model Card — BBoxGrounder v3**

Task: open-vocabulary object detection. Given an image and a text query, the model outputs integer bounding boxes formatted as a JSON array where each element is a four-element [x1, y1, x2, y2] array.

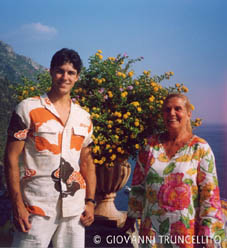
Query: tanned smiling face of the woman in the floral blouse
[[163, 97, 191, 130]]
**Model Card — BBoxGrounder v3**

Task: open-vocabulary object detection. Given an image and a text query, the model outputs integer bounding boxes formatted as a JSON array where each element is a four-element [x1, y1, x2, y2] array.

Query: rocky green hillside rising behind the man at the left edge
[[0, 41, 44, 161]]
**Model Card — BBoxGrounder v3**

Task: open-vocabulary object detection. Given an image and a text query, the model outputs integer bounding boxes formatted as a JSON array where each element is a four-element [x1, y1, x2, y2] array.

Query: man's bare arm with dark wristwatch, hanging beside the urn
[[80, 147, 96, 226]]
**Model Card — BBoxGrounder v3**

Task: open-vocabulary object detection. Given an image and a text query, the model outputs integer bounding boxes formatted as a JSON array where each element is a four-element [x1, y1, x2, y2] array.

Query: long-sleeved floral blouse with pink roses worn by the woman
[[128, 135, 225, 248]]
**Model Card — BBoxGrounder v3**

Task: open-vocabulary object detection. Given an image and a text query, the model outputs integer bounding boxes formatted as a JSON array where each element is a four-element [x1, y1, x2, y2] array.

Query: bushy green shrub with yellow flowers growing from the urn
[[13, 50, 201, 166]]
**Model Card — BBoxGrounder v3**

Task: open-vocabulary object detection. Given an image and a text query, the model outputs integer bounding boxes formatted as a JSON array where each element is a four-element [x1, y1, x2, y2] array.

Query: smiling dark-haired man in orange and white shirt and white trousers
[[5, 48, 96, 248]]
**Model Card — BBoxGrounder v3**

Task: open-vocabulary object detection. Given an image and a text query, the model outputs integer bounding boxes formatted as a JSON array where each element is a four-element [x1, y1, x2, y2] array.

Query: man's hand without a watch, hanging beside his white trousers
[[13, 204, 31, 232]]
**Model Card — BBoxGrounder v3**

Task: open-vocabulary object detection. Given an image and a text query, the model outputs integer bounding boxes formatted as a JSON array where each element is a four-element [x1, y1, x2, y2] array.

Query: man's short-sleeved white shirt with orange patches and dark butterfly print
[[8, 94, 92, 217]]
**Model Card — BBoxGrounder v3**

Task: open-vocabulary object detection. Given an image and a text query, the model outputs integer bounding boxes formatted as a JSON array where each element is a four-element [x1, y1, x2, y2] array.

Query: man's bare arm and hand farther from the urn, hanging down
[[4, 140, 31, 232]]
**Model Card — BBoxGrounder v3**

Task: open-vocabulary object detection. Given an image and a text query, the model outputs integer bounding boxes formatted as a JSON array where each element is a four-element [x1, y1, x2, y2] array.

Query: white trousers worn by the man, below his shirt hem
[[12, 207, 85, 248]]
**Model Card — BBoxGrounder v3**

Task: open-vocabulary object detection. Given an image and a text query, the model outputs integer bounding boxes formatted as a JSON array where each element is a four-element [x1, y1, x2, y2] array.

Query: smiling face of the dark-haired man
[[50, 63, 79, 95]]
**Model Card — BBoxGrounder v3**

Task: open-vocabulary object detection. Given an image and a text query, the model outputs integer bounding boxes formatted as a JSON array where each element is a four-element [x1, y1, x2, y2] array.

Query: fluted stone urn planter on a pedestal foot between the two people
[[95, 161, 131, 226]]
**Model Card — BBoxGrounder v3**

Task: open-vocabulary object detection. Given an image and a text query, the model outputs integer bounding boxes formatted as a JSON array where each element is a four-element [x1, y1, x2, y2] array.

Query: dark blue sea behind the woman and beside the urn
[[115, 124, 227, 211]]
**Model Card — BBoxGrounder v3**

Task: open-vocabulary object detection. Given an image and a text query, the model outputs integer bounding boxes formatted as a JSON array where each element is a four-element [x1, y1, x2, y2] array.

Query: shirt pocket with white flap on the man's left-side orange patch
[[34, 125, 62, 155]]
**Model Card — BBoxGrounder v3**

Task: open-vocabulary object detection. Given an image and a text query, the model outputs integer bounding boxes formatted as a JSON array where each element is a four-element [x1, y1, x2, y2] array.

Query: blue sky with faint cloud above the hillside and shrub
[[0, 0, 227, 123]]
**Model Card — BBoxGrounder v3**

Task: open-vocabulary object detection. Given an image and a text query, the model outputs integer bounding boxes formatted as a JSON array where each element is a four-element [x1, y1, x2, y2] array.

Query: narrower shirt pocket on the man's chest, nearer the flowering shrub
[[70, 126, 88, 151]]
